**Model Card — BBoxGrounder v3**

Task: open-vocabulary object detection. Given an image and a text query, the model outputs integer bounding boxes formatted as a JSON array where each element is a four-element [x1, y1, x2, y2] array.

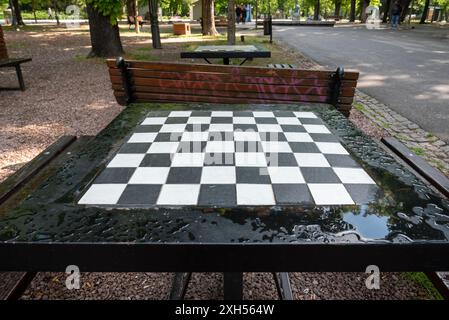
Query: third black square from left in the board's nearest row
[[273, 184, 314, 205]]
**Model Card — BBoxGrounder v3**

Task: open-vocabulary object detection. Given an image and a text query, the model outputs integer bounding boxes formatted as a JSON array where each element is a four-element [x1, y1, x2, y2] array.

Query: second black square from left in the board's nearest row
[[198, 184, 237, 207]]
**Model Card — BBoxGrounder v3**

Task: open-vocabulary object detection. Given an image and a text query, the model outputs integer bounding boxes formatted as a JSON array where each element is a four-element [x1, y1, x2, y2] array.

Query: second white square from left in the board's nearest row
[[157, 184, 200, 205]]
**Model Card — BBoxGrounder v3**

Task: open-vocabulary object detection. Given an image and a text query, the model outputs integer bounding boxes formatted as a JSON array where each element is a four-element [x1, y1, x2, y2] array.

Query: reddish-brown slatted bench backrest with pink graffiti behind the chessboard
[[107, 58, 359, 116]]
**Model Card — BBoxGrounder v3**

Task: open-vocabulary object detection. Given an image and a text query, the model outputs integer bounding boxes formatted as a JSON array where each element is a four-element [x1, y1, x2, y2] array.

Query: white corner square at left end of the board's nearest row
[[78, 183, 126, 204]]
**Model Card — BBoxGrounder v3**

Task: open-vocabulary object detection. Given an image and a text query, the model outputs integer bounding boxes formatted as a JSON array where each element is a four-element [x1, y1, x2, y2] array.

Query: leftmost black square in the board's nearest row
[[117, 184, 162, 206]]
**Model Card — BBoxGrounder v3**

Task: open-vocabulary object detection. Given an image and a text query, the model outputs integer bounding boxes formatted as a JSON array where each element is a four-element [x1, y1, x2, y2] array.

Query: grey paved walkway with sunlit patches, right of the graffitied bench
[[274, 26, 449, 142]]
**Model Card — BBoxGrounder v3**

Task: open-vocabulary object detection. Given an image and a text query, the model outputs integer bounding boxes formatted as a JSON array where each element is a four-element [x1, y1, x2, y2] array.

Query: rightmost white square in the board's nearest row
[[307, 183, 354, 205]]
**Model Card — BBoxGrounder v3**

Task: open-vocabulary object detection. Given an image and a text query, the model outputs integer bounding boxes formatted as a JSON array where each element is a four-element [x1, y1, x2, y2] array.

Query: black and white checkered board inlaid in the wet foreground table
[[79, 111, 378, 207]]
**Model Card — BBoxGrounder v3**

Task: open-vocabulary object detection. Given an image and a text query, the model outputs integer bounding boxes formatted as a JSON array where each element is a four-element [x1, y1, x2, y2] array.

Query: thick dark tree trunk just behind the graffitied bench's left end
[[86, 4, 123, 57]]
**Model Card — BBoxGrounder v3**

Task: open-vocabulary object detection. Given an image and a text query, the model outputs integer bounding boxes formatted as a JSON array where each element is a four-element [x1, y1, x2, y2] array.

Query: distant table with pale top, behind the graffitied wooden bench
[[181, 45, 271, 65]]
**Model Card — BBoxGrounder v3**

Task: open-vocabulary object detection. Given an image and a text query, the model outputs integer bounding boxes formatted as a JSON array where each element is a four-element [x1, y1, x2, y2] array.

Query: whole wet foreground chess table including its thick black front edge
[[0, 103, 449, 298]]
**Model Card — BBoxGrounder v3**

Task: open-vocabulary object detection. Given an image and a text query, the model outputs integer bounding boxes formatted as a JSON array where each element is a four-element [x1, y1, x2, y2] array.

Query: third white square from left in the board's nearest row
[[236, 184, 276, 206]]
